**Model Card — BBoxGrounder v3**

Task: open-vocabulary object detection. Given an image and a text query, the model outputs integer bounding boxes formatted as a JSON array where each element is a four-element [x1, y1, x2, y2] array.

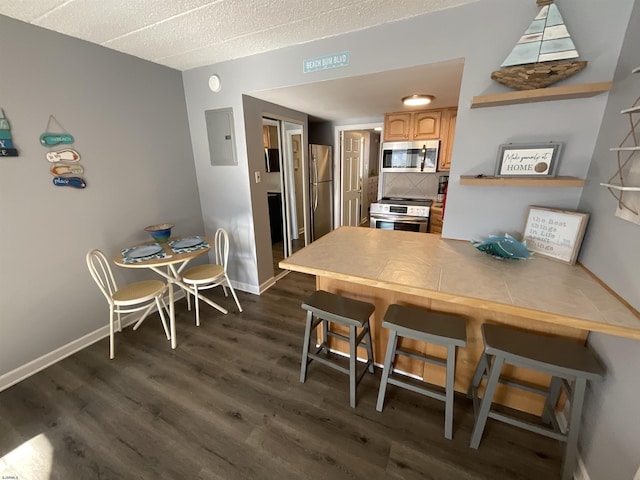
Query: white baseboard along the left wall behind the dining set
[[0, 289, 189, 392]]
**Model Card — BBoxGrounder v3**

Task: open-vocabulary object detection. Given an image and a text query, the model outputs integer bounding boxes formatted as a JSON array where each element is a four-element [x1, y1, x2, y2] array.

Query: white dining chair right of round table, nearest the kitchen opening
[[182, 228, 242, 326]]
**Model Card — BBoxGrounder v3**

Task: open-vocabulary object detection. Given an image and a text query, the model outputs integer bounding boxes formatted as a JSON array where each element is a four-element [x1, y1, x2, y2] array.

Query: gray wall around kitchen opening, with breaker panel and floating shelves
[[183, 0, 633, 291]]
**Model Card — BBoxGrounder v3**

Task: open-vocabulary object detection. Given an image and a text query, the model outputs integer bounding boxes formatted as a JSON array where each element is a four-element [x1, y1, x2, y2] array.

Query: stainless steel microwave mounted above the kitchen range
[[380, 140, 440, 173]]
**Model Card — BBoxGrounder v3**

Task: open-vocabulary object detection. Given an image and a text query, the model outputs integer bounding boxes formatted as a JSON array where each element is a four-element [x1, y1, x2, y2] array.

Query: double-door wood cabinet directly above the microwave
[[384, 110, 442, 142]]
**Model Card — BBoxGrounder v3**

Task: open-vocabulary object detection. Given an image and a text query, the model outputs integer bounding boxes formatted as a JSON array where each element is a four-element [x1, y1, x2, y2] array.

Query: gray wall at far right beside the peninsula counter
[[580, 4, 640, 480]]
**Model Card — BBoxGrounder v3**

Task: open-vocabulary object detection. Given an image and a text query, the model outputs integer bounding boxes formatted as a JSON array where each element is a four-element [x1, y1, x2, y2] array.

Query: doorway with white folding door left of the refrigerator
[[263, 117, 307, 279]]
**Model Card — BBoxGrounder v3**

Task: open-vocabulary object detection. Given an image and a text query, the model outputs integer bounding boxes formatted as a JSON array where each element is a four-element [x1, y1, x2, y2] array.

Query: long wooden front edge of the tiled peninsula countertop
[[279, 255, 640, 340]]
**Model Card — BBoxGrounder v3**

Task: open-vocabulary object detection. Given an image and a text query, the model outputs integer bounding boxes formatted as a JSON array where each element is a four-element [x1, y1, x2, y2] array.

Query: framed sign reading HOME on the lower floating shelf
[[496, 142, 562, 177]]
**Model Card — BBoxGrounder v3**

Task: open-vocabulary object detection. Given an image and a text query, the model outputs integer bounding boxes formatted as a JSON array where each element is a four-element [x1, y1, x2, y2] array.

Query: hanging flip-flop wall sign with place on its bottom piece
[[40, 115, 87, 188]]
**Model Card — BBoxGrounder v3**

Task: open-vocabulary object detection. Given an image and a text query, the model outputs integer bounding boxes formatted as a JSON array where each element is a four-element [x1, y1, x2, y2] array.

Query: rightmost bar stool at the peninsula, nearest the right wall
[[469, 324, 605, 480]]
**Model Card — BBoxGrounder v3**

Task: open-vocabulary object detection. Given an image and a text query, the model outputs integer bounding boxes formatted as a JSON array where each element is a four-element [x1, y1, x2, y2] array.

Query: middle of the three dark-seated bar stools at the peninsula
[[376, 305, 467, 440]]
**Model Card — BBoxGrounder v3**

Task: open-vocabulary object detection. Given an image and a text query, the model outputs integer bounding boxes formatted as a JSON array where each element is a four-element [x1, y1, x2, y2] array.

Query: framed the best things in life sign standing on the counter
[[522, 207, 589, 265]]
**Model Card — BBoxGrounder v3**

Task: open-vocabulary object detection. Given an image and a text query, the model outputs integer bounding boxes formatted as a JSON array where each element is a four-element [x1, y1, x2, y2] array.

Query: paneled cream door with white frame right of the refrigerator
[[335, 123, 382, 226]]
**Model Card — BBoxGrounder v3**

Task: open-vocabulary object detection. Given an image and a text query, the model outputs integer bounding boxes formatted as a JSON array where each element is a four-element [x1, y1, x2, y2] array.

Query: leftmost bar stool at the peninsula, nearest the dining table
[[300, 290, 375, 408]]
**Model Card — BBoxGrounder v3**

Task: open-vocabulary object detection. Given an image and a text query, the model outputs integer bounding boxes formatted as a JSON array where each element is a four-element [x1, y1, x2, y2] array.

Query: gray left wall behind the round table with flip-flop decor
[[0, 16, 203, 378]]
